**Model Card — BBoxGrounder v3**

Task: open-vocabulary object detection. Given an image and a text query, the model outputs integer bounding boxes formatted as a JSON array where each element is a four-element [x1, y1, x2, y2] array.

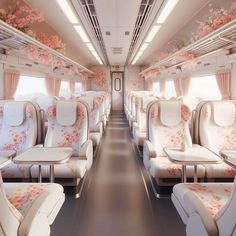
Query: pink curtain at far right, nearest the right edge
[[216, 70, 231, 99]]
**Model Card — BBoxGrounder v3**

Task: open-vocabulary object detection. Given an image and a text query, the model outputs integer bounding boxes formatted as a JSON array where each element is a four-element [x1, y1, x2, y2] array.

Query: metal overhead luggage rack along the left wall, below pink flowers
[[0, 20, 94, 75]]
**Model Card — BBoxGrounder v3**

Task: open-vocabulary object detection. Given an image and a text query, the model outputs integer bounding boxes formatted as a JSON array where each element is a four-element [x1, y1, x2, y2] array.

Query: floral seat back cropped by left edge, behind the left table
[[0, 101, 39, 154]]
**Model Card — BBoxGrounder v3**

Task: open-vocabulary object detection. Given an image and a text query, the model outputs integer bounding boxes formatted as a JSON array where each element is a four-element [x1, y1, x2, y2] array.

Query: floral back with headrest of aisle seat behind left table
[[44, 101, 89, 155]]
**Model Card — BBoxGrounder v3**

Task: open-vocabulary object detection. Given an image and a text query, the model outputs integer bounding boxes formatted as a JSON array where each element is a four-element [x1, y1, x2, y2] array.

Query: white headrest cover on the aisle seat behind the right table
[[160, 101, 182, 126]]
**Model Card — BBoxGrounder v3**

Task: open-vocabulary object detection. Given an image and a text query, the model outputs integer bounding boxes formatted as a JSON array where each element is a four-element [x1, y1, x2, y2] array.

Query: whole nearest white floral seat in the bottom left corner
[[0, 173, 65, 236]]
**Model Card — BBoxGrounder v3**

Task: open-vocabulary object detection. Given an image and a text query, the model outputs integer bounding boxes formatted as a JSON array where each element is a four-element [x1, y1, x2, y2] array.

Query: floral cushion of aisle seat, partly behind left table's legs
[[31, 157, 87, 179]]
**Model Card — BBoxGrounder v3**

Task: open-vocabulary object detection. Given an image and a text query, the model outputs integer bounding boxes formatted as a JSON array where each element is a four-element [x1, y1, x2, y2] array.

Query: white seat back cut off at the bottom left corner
[[0, 171, 22, 236]]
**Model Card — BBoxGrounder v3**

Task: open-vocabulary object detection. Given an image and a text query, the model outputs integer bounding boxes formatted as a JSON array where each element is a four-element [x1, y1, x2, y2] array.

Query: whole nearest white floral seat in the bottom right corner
[[172, 178, 236, 236]]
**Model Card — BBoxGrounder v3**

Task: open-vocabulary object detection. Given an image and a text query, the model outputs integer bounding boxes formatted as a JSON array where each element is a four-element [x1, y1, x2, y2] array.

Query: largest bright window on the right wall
[[188, 75, 222, 100]]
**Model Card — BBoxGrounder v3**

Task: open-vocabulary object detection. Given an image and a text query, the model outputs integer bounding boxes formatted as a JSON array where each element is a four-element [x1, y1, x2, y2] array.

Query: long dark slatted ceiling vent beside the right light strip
[[126, 0, 154, 63]]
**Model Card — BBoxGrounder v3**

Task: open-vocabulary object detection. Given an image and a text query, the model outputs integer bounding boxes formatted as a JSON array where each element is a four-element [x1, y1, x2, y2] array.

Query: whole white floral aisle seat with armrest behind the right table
[[143, 100, 205, 185]]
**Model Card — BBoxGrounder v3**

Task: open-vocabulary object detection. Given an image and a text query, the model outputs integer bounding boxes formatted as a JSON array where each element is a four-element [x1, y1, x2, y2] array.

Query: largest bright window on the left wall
[[14, 75, 48, 100]]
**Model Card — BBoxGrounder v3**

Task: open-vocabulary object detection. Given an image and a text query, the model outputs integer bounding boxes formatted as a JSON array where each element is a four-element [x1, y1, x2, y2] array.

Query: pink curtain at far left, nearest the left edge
[[4, 70, 20, 99]]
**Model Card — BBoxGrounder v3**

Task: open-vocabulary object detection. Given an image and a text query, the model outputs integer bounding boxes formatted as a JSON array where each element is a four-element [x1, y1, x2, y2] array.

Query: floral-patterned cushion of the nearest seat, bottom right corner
[[173, 183, 233, 217]]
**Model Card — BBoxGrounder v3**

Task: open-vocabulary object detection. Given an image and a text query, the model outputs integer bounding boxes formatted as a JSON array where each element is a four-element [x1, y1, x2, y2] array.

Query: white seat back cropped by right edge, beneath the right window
[[198, 100, 236, 153]]
